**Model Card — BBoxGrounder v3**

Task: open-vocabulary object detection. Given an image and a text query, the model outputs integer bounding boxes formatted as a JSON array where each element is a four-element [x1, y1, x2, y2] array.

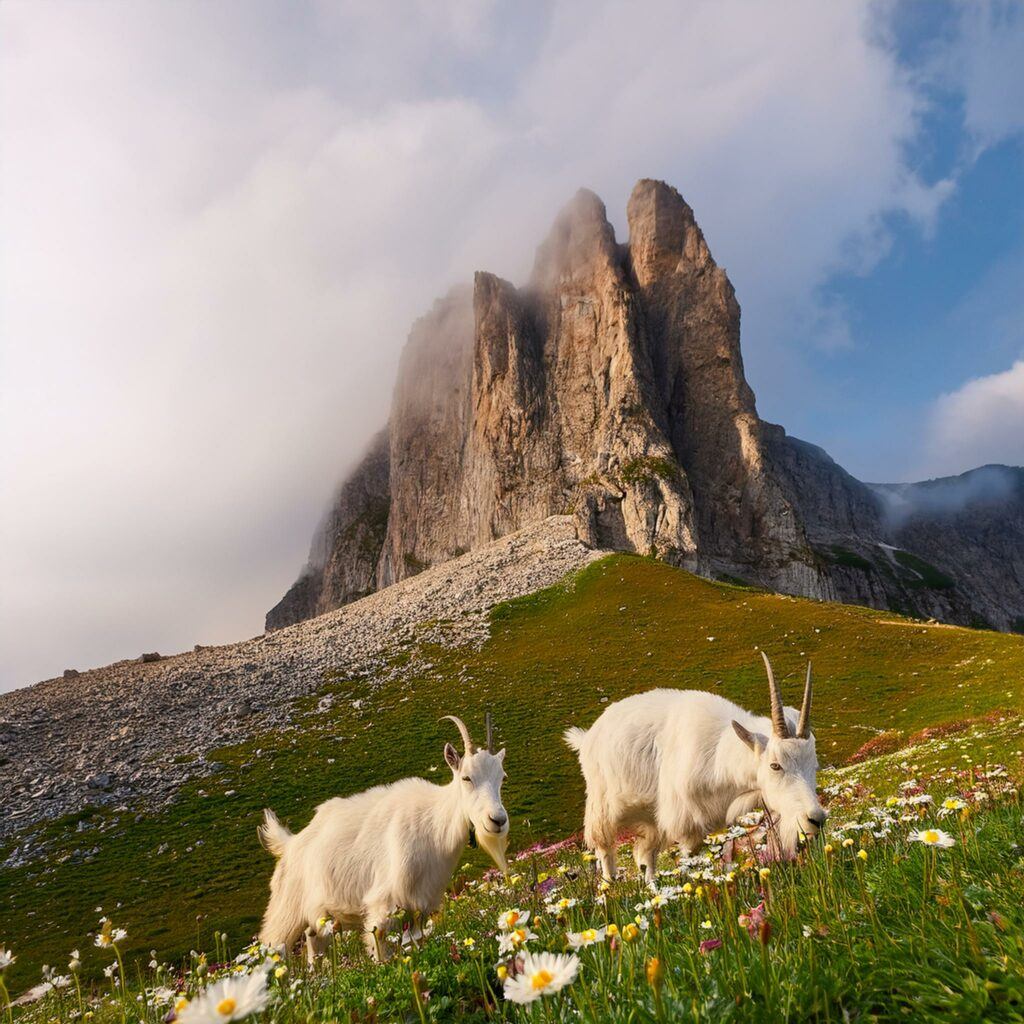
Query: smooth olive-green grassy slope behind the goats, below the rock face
[[0, 556, 1024, 989]]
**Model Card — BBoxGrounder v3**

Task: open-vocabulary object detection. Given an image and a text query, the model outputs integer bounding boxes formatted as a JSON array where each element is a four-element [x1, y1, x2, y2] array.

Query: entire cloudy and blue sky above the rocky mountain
[[0, 0, 1024, 689]]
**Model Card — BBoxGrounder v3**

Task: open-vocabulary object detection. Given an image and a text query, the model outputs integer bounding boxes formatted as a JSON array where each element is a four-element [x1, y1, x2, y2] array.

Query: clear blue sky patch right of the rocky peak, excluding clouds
[[787, 3, 1024, 479]]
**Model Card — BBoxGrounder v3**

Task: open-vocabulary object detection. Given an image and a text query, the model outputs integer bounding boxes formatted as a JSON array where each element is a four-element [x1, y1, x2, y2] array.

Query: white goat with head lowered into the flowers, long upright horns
[[565, 653, 825, 883]]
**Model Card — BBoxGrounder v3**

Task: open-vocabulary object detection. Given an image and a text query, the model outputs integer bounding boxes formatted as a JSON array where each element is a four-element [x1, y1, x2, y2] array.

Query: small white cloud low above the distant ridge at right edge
[[925, 358, 1024, 476]]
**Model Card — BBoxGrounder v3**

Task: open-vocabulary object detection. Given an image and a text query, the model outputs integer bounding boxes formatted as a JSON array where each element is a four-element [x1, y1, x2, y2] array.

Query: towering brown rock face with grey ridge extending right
[[267, 180, 1024, 629]]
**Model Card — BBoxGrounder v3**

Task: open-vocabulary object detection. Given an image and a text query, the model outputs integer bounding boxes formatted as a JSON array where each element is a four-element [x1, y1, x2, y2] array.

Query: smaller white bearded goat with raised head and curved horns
[[258, 715, 509, 961]]
